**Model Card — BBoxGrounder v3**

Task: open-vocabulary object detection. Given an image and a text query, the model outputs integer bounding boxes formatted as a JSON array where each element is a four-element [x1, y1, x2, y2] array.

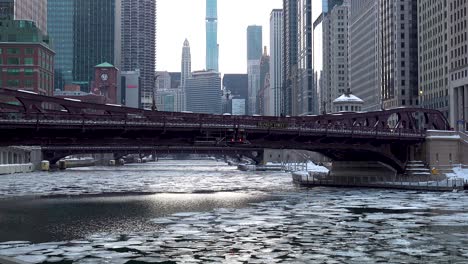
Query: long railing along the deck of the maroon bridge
[[0, 112, 426, 137]]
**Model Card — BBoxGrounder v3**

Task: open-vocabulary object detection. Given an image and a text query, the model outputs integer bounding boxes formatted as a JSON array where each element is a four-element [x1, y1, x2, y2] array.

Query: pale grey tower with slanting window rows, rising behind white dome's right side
[[349, 0, 382, 111]]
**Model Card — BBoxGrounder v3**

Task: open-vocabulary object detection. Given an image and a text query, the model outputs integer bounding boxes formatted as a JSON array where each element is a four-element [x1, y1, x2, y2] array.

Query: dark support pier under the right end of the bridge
[[330, 161, 397, 178]]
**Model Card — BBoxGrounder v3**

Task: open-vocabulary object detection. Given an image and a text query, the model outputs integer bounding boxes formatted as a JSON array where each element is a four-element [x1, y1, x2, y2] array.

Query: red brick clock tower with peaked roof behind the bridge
[[91, 62, 119, 104]]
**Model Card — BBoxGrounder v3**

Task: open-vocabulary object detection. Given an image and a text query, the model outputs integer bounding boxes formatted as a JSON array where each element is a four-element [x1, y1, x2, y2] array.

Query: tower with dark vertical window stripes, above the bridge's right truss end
[[380, 0, 419, 109]]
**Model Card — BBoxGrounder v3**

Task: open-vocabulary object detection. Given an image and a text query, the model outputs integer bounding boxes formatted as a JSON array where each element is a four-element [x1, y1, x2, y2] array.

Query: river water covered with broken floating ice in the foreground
[[0, 161, 468, 264]]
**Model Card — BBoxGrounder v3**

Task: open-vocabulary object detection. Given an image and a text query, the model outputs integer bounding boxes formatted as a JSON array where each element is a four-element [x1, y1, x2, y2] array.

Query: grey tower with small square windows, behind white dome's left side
[[321, 0, 349, 113]]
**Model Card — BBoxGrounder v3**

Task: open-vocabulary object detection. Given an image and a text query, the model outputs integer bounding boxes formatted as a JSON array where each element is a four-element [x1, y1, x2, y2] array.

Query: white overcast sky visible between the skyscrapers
[[156, 0, 283, 74]]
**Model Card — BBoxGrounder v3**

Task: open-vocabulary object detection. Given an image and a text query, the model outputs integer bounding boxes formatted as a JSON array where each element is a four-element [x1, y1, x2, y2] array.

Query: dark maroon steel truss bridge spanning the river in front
[[0, 88, 450, 172]]
